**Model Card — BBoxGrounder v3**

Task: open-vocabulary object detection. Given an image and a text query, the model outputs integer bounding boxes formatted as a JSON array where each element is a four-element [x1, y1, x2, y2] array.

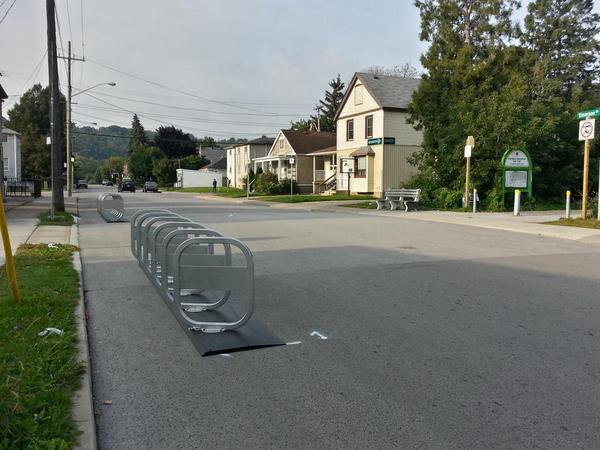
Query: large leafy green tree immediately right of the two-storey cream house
[[409, 0, 527, 202]]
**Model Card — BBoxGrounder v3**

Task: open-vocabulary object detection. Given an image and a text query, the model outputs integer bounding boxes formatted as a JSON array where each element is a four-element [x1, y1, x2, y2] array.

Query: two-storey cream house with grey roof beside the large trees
[[336, 73, 422, 196]]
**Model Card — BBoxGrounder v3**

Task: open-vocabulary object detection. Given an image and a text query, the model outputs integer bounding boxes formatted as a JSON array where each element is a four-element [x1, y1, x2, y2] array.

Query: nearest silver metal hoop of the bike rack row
[[173, 237, 254, 333]]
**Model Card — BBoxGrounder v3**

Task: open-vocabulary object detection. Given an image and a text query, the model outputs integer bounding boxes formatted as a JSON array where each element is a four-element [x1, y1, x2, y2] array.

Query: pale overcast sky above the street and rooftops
[[0, 0, 596, 139]]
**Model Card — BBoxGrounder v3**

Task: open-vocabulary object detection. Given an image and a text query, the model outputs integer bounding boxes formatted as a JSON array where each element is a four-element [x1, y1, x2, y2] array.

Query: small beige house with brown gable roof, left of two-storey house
[[253, 130, 336, 193]]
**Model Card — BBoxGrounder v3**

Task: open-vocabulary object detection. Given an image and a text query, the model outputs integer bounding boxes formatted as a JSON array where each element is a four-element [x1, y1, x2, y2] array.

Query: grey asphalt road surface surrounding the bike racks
[[79, 187, 600, 449]]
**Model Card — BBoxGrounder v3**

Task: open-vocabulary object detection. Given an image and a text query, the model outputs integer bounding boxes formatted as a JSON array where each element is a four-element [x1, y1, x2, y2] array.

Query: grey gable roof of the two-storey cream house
[[335, 72, 421, 120]]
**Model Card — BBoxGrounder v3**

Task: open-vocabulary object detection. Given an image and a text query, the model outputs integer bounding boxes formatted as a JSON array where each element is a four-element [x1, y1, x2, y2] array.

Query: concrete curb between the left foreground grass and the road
[[70, 202, 97, 450]]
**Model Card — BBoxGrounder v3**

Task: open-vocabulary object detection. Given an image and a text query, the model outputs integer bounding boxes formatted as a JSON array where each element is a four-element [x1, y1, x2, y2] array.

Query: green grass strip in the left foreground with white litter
[[0, 244, 83, 450]]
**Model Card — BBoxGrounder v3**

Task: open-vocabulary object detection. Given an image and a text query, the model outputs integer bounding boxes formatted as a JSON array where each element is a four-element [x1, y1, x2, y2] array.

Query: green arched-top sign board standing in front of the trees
[[500, 149, 533, 216]]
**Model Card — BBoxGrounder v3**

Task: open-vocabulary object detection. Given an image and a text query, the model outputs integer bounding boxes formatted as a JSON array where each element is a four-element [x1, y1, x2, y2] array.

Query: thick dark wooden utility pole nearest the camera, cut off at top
[[46, 0, 65, 217]]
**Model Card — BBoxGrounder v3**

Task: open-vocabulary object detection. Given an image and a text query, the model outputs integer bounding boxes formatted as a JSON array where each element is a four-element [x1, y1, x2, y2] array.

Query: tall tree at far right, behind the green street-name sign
[[521, 0, 600, 197]]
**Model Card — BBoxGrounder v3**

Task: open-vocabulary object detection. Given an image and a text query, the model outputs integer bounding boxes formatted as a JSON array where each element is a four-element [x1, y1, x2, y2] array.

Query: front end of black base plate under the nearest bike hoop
[[173, 304, 285, 356]]
